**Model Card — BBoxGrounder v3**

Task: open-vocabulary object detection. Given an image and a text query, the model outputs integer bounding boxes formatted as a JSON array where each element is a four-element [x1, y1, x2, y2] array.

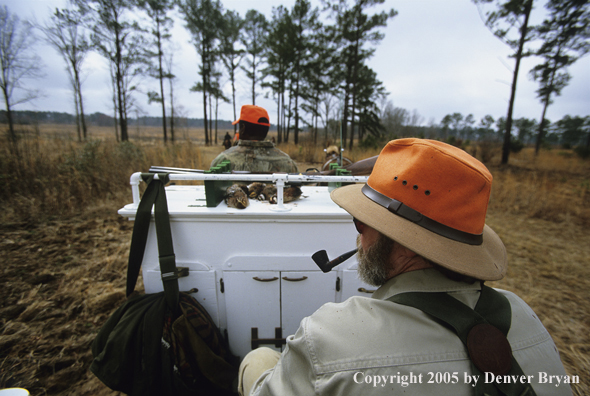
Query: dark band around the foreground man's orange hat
[[361, 184, 483, 245]]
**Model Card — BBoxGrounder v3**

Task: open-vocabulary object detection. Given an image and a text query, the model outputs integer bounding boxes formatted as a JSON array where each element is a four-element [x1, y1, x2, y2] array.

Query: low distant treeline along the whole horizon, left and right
[[5, 108, 590, 157]]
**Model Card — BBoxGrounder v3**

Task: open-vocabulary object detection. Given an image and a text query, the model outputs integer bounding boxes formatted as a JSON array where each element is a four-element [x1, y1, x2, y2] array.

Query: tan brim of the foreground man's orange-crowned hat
[[330, 184, 508, 281]]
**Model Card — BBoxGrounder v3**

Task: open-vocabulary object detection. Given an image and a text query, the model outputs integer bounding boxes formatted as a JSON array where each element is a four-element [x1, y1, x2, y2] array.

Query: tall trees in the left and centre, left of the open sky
[[0, 0, 396, 145]]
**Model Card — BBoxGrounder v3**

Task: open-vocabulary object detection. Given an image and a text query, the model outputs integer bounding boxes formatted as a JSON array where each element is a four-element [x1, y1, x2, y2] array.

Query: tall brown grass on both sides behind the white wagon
[[0, 127, 590, 226]]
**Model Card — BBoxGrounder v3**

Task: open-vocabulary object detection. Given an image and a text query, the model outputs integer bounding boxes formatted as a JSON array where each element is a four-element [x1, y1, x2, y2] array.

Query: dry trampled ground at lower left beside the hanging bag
[[0, 204, 132, 395]]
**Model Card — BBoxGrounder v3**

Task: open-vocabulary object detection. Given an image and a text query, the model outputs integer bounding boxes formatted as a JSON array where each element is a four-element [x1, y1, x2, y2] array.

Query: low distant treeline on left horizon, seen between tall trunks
[[0, 110, 233, 129]]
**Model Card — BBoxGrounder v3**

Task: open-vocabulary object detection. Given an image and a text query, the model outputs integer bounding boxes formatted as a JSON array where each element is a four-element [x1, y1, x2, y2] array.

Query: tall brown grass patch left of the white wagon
[[0, 136, 208, 222]]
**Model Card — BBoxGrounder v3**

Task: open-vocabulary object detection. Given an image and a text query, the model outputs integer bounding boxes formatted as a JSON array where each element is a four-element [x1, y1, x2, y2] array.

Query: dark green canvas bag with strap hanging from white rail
[[90, 173, 238, 396]]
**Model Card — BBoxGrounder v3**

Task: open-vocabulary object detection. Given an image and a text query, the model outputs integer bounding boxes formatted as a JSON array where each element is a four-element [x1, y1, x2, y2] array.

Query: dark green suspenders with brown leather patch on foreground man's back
[[388, 284, 536, 396]]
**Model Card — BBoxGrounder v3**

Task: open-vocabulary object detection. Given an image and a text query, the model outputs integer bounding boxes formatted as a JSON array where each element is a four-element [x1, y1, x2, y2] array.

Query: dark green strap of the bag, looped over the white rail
[[127, 173, 179, 311]]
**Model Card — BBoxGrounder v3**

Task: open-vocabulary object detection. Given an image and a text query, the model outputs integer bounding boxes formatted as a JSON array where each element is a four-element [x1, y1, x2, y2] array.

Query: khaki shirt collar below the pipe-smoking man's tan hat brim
[[373, 268, 481, 300]]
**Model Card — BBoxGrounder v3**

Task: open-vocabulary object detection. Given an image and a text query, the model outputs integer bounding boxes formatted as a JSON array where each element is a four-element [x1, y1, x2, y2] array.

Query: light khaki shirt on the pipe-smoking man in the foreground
[[251, 269, 575, 396]]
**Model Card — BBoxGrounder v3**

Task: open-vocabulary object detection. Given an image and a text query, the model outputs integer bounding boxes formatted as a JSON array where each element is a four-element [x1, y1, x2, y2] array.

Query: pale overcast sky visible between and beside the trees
[[0, 0, 590, 125]]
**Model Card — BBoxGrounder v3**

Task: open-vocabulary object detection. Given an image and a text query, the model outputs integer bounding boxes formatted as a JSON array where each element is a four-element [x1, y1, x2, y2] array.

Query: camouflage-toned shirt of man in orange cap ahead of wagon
[[211, 140, 298, 173]]
